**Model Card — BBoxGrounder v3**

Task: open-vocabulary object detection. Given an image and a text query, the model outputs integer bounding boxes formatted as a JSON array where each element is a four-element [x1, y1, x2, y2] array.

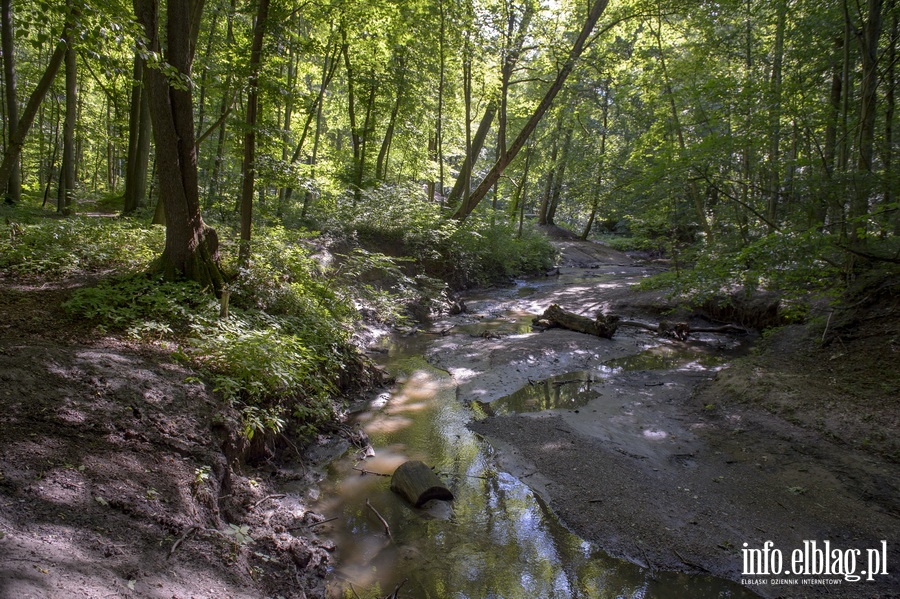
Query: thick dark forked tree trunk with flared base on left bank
[[134, 0, 224, 294]]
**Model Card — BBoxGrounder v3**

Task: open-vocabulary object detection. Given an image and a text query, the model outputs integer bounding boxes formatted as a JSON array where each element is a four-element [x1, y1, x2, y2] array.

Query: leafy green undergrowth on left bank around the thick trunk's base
[[0, 210, 417, 446]]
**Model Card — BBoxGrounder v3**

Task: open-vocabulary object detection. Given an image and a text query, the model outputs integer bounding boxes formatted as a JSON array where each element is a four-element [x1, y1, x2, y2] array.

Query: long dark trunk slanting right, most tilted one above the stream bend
[[453, 0, 608, 219]]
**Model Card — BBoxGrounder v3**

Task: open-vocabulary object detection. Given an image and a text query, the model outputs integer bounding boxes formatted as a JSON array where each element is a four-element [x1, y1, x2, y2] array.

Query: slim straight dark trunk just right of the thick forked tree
[[238, 0, 269, 266]]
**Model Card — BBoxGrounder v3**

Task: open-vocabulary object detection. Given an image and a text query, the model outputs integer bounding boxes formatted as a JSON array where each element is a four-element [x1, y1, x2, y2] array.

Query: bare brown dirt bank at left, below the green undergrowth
[[0, 280, 333, 599]]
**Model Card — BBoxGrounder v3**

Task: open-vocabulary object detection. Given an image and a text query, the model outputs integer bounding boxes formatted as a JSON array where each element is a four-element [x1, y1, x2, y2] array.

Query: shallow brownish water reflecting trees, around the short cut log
[[316, 319, 755, 599]]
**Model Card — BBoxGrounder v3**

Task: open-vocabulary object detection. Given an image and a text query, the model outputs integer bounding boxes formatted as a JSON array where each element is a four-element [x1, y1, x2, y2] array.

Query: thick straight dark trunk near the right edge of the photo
[[850, 0, 883, 242]]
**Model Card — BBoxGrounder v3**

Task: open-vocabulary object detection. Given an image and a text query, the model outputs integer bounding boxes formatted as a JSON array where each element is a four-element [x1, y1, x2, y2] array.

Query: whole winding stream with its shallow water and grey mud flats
[[298, 241, 900, 599]]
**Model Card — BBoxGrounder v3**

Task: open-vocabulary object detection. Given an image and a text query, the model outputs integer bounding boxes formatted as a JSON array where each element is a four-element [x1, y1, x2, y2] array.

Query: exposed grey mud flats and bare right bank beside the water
[[430, 241, 900, 598]]
